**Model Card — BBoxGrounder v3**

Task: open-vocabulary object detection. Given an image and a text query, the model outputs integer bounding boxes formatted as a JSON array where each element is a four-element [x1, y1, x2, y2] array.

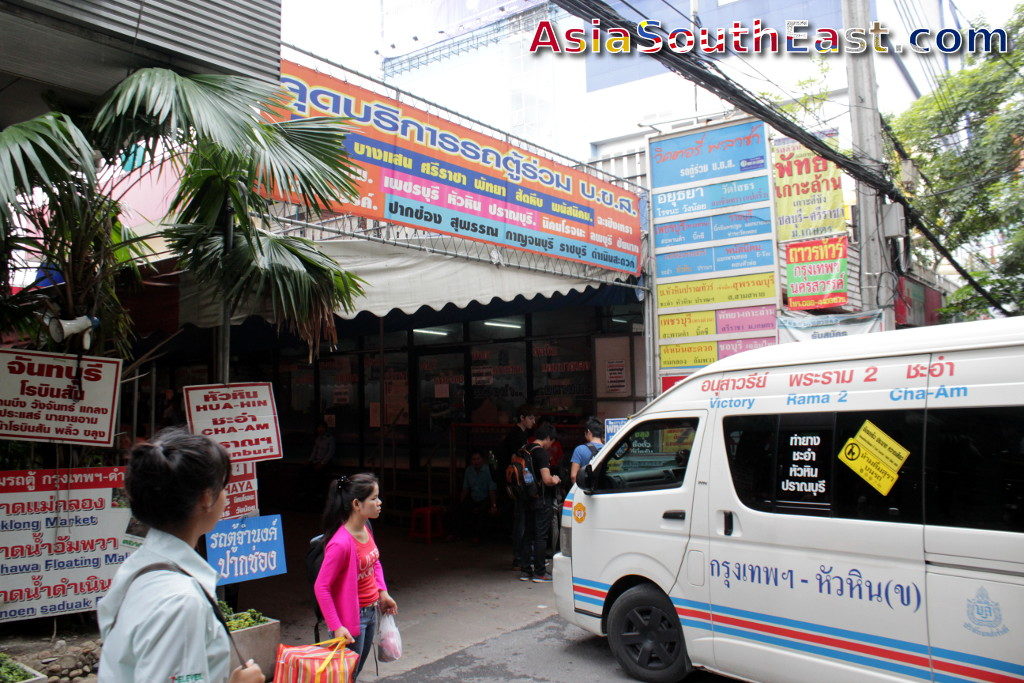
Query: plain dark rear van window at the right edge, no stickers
[[925, 405, 1024, 532]]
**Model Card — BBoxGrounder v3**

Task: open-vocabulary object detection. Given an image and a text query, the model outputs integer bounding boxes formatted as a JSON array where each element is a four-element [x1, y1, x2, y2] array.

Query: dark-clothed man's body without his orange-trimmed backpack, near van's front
[[519, 423, 560, 584]]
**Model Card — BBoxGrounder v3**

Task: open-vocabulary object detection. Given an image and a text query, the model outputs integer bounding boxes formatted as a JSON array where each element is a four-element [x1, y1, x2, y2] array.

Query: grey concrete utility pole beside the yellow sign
[[843, 0, 896, 330]]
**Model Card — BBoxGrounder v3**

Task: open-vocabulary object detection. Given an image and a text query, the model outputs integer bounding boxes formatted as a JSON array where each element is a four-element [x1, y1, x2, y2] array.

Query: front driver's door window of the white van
[[594, 418, 699, 493]]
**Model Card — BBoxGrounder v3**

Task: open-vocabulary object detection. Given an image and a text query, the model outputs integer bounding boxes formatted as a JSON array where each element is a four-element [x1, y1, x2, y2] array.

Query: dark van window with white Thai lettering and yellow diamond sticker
[[722, 411, 924, 523]]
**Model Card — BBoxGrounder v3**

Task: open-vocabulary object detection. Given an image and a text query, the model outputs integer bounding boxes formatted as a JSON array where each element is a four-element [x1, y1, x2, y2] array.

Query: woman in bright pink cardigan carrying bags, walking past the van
[[313, 474, 398, 680]]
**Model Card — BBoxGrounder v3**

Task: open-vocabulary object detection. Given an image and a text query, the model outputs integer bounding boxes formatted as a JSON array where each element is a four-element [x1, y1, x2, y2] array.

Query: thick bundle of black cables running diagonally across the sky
[[553, 0, 1010, 315]]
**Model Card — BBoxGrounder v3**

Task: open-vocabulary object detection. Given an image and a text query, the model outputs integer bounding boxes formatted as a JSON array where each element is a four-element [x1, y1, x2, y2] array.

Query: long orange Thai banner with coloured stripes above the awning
[[281, 61, 640, 274]]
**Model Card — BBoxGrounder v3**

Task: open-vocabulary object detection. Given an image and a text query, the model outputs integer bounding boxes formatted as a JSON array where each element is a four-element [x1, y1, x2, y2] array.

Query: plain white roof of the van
[[647, 316, 1024, 410]]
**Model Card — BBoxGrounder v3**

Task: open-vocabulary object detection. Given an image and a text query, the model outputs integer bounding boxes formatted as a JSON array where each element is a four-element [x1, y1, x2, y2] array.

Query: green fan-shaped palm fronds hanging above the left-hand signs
[[0, 69, 361, 356]]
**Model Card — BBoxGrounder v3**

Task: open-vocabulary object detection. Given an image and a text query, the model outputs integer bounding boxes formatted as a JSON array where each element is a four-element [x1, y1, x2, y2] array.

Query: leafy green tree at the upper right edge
[[893, 5, 1024, 318]]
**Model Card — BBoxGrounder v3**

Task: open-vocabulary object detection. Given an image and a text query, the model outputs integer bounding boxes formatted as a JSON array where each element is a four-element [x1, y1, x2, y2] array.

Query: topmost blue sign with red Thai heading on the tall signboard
[[650, 121, 768, 189]]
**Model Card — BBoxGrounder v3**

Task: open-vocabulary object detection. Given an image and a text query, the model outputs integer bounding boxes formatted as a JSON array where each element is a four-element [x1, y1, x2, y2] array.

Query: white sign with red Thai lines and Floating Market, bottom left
[[0, 467, 136, 622]]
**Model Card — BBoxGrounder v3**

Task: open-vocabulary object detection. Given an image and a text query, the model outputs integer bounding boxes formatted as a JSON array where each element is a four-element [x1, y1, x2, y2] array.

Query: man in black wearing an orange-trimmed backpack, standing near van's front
[[506, 424, 561, 584]]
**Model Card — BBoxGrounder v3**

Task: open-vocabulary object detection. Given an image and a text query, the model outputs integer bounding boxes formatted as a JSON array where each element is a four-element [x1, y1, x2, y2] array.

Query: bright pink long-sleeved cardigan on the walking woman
[[313, 526, 387, 638]]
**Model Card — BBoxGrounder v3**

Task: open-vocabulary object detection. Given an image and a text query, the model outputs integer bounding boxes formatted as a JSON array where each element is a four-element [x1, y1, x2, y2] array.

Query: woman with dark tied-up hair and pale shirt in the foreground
[[96, 428, 265, 683]]
